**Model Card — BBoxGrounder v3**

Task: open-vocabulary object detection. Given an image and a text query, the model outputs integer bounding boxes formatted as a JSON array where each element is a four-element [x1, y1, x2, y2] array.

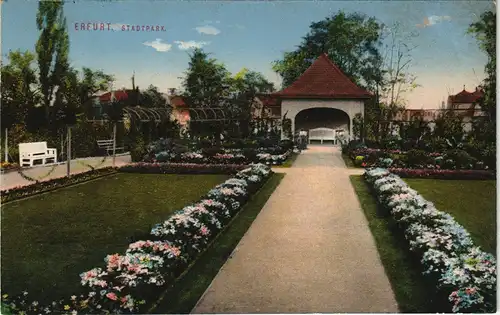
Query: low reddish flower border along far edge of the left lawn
[[118, 162, 246, 174]]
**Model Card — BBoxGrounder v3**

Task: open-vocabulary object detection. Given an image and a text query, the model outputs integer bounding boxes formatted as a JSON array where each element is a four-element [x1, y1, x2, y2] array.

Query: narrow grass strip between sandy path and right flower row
[[350, 175, 436, 313]]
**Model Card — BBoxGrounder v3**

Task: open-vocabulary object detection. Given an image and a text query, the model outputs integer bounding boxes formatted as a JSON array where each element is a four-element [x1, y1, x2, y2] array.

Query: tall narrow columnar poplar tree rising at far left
[[36, 0, 70, 126]]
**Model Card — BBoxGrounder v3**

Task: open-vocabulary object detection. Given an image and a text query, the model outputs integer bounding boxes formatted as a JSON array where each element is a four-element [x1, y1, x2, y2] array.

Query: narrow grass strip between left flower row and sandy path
[[153, 173, 285, 314]]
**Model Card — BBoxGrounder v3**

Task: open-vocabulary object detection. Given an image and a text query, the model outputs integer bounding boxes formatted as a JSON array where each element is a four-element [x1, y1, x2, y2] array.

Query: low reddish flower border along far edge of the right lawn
[[389, 168, 496, 180]]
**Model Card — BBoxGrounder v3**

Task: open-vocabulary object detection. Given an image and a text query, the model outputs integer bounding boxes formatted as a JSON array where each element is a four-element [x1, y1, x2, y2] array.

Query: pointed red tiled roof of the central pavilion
[[272, 54, 371, 99]]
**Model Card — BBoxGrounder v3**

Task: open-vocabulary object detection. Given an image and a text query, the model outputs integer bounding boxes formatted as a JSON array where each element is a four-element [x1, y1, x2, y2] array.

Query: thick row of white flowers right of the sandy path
[[364, 168, 496, 312]]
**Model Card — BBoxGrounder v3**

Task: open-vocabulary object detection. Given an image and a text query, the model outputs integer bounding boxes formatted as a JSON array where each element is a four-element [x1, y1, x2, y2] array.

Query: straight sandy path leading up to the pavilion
[[192, 146, 398, 313]]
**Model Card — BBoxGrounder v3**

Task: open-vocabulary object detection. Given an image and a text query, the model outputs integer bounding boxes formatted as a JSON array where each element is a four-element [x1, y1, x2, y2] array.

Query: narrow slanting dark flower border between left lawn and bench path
[[0, 167, 116, 203]]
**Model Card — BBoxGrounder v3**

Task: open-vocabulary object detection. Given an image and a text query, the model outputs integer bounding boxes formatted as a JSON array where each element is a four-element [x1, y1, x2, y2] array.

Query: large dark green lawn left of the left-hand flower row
[[1, 173, 228, 302]]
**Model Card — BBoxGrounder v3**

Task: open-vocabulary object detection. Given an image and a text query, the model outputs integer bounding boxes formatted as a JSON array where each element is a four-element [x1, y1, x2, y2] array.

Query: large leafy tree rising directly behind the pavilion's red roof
[[273, 11, 382, 87]]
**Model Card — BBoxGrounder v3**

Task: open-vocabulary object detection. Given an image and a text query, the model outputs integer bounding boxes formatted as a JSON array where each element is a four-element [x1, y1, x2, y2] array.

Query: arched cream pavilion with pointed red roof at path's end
[[271, 54, 372, 143]]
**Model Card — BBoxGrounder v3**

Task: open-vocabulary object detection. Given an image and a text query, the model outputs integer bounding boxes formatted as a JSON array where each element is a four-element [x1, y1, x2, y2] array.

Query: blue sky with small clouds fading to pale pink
[[1, 0, 494, 108]]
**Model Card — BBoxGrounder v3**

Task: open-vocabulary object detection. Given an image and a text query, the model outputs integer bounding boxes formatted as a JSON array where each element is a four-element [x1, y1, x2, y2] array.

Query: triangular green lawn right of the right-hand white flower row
[[405, 178, 497, 255]]
